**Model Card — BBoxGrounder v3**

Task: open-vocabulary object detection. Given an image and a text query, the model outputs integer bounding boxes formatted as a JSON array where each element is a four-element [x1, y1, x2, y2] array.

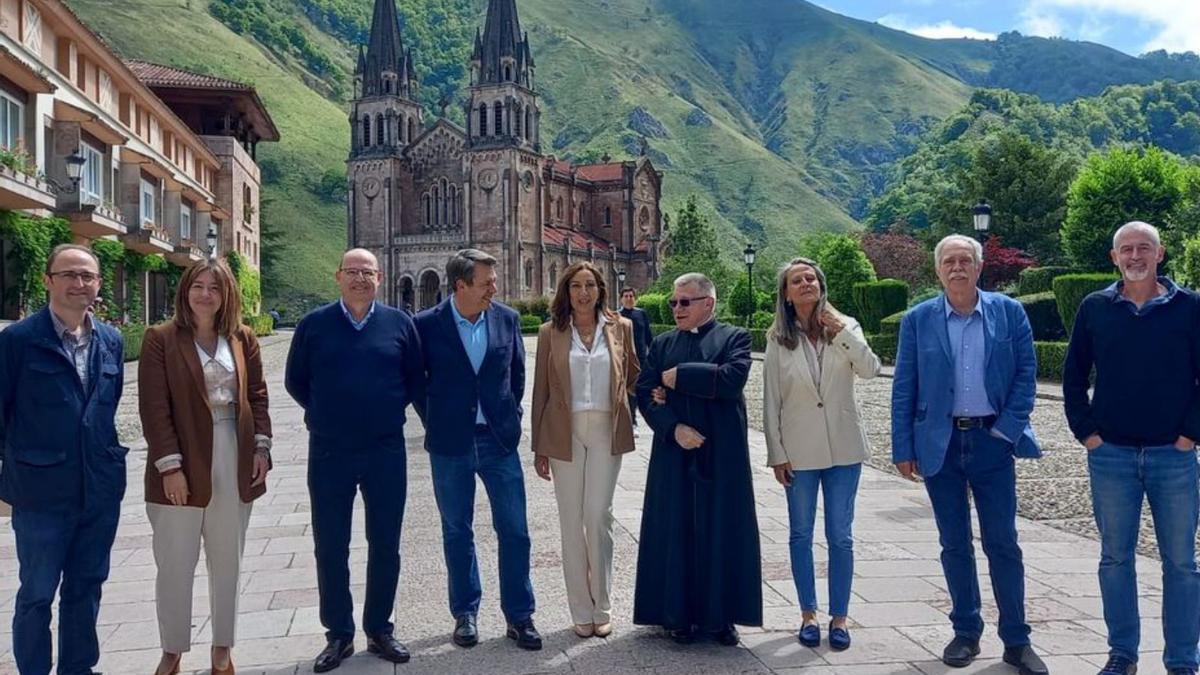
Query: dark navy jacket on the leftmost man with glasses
[[0, 309, 128, 510]]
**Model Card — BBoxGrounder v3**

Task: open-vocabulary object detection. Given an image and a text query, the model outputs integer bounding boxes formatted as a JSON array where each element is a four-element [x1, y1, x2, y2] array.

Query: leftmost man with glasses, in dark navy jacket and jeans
[[0, 244, 128, 675]]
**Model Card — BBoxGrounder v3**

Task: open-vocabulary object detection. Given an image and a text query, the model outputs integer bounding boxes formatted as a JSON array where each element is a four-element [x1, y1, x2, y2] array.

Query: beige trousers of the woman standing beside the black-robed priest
[[550, 411, 620, 625]]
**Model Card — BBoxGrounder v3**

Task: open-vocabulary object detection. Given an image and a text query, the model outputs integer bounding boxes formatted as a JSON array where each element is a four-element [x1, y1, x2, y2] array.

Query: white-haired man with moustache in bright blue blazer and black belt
[[892, 234, 1048, 675]]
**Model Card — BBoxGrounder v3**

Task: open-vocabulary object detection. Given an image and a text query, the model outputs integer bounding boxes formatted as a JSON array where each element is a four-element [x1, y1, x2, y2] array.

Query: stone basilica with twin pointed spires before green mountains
[[347, 0, 662, 310]]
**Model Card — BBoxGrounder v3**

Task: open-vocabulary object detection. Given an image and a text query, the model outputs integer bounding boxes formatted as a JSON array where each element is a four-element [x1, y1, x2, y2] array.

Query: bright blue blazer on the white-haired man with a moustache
[[892, 291, 1042, 476]]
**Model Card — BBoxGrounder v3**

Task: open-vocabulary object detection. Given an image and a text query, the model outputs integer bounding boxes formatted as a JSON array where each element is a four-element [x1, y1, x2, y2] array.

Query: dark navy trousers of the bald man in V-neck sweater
[[308, 436, 408, 640]]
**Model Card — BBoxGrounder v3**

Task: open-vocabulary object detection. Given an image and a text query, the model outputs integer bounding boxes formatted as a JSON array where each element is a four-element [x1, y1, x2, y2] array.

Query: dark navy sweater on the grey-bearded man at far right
[[1062, 279, 1200, 447]]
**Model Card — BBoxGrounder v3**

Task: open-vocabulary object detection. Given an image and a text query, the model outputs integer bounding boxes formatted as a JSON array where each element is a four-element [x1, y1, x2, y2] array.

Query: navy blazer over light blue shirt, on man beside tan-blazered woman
[[413, 297, 524, 455]]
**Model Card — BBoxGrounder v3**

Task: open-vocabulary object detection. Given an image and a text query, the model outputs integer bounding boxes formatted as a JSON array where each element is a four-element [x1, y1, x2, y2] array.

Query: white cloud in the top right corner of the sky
[[1022, 0, 1200, 53]]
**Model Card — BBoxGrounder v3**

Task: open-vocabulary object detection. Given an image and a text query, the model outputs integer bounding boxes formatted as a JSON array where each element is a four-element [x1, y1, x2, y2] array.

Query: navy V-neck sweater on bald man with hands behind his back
[[284, 303, 425, 446]]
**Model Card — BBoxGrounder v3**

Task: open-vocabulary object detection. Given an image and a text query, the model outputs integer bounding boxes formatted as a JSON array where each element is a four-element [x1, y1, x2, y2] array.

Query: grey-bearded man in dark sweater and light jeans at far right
[[1062, 221, 1200, 675]]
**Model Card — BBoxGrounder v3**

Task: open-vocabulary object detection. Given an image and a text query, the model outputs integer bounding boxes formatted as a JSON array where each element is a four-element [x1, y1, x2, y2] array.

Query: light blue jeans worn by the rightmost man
[[1087, 443, 1200, 669]]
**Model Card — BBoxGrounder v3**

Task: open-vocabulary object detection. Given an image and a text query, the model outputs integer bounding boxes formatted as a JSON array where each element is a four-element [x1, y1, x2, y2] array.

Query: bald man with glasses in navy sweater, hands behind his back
[[284, 249, 425, 673]]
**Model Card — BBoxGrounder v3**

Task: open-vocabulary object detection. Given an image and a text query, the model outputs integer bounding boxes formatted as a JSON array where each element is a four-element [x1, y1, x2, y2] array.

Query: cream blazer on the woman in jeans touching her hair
[[762, 316, 880, 471]]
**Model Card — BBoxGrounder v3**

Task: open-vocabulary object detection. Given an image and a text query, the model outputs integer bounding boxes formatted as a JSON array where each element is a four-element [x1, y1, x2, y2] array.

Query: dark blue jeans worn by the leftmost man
[[12, 502, 121, 675]]
